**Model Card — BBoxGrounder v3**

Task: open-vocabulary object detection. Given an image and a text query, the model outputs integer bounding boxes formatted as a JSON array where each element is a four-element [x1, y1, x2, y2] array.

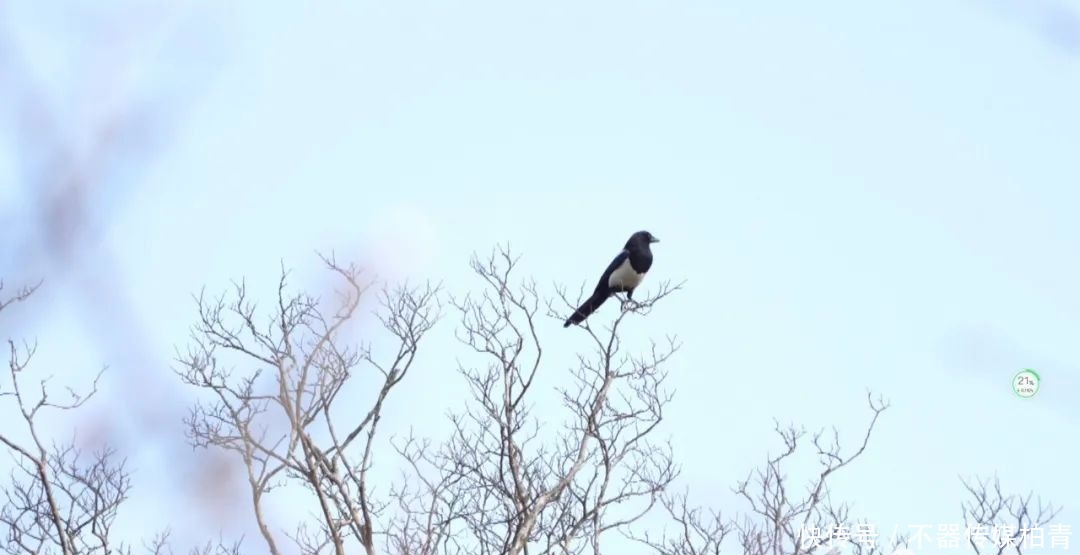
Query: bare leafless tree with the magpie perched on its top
[[388, 248, 679, 554]]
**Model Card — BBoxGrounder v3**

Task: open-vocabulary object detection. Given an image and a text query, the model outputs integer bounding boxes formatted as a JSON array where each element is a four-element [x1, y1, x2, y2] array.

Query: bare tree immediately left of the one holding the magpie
[[177, 251, 437, 555]]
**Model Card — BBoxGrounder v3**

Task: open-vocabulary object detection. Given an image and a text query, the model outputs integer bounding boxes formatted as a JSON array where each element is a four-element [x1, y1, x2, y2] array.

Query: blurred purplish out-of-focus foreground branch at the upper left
[[0, 2, 217, 447]]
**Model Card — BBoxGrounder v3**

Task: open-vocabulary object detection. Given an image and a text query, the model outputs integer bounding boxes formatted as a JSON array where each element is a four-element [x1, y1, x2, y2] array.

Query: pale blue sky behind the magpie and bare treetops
[[0, 0, 1080, 553]]
